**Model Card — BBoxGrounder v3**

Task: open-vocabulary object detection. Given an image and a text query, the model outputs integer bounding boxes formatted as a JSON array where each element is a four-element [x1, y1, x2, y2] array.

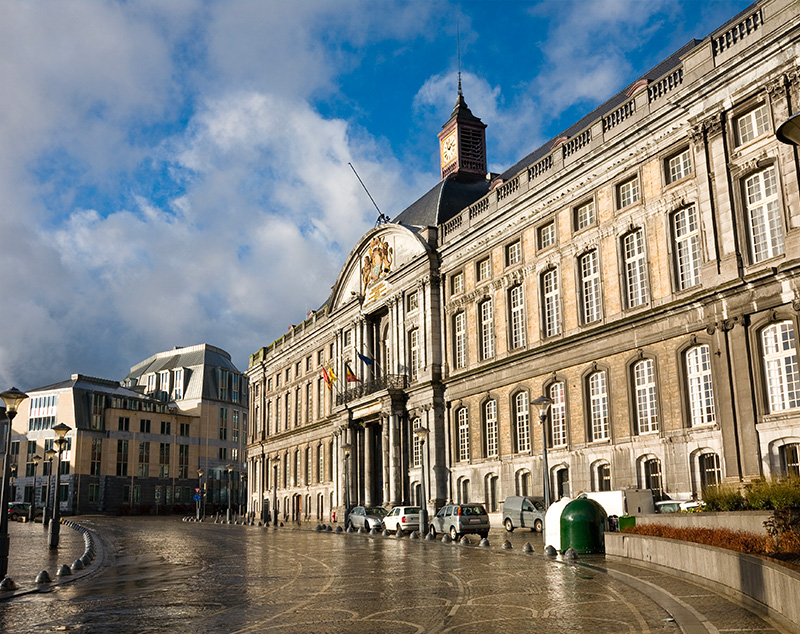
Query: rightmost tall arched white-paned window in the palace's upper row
[[744, 165, 784, 262]]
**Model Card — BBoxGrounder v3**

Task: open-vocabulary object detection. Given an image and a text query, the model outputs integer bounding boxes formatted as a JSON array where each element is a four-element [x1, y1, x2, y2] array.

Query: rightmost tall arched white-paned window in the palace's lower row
[[761, 321, 800, 412]]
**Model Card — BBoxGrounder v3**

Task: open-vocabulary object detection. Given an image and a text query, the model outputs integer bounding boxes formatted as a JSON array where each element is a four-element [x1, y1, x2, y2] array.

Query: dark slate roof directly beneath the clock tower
[[392, 174, 489, 227]]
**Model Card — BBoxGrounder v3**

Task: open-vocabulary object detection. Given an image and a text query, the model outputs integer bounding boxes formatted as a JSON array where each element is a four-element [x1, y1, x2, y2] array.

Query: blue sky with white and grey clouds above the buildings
[[0, 0, 749, 389]]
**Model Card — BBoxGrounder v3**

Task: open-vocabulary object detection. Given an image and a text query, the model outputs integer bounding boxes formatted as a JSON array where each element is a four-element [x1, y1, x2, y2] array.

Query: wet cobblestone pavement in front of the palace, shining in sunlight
[[0, 517, 784, 634]]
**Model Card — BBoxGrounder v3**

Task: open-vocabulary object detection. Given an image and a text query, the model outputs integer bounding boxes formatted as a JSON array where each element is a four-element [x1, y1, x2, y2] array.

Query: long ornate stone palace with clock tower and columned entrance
[[246, 0, 800, 521]]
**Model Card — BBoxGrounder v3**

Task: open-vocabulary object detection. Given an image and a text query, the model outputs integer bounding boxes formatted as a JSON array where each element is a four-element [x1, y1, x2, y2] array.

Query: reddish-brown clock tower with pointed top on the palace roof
[[438, 77, 486, 179]]
